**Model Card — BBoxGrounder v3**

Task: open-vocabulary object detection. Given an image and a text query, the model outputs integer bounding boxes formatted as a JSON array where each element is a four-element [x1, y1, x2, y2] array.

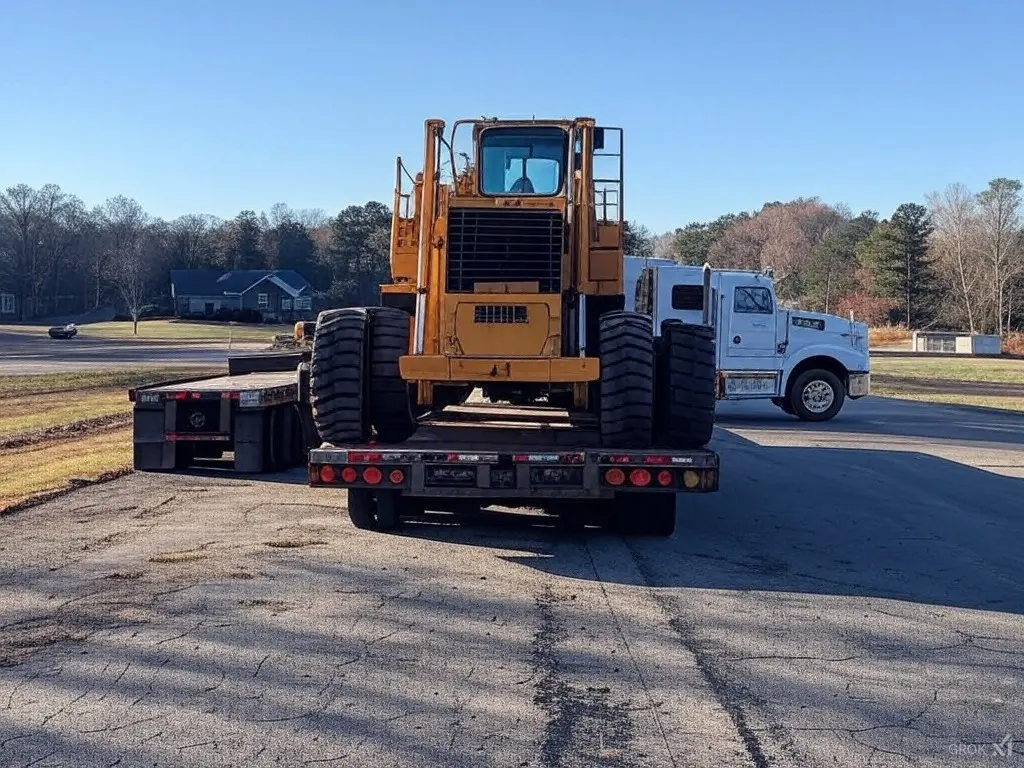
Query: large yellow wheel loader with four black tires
[[309, 118, 715, 450]]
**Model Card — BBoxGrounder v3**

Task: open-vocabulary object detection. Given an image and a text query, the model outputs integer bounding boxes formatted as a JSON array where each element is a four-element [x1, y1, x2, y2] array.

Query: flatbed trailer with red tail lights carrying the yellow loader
[[308, 402, 719, 536]]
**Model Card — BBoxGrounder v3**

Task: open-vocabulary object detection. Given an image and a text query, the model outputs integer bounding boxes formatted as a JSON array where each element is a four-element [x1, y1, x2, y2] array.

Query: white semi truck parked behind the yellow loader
[[625, 257, 870, 421]]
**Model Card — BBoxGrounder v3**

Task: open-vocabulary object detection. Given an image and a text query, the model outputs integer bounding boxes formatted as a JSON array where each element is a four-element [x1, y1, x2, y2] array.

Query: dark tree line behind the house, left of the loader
[[0, 184, 391, 321]]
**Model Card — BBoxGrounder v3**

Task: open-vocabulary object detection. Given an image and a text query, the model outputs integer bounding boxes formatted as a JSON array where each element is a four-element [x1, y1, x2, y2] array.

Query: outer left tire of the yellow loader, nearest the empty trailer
[[309, 307, 370, 443]]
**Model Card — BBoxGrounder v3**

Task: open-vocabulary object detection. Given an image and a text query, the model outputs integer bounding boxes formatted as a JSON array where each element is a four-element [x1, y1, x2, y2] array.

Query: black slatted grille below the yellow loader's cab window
[[447, 208, 565, 293]]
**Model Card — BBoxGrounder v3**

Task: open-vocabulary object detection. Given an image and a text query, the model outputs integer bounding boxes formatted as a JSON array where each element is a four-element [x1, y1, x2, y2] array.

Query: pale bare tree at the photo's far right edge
[[978, 178, 1024, 336]]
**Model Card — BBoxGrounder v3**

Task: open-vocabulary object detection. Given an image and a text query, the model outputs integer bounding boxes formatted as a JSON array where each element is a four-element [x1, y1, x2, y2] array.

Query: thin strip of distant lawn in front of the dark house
[[0, 319, 295, 344]]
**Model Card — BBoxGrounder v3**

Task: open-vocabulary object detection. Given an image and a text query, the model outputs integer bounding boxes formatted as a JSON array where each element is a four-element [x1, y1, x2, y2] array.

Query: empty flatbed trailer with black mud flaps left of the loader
[[128, 352, 319, 473]]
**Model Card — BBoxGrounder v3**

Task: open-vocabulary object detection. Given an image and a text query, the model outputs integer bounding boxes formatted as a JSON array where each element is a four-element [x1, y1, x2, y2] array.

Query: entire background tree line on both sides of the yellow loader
[[0, 178, 1024, 333]]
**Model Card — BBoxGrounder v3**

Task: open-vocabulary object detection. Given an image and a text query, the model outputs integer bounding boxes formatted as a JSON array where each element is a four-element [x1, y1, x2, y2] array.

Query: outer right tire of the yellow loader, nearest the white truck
[[656, 321, 716, 450]]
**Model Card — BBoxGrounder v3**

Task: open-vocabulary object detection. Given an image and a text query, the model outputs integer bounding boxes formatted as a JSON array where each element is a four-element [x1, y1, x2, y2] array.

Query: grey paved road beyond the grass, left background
[[0, 332, 267, 376]]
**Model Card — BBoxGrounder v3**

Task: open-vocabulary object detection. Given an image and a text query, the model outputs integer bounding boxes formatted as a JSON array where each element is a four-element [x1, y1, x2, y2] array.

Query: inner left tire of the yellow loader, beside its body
[[370, 306, 417, 442]]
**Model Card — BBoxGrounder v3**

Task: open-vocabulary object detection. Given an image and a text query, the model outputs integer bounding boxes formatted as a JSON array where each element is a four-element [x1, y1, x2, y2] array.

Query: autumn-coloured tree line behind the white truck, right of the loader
[[627, 178, 1024, 334]]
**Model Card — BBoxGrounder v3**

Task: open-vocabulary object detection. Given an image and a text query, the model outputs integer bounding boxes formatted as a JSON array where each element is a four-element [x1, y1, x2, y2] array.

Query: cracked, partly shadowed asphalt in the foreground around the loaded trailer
[[0, 398, 1024, 768]]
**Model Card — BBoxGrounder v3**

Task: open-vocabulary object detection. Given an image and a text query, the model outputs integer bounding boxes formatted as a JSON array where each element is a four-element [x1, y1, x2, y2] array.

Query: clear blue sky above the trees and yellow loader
[[0, 0, 1024, 231]]
